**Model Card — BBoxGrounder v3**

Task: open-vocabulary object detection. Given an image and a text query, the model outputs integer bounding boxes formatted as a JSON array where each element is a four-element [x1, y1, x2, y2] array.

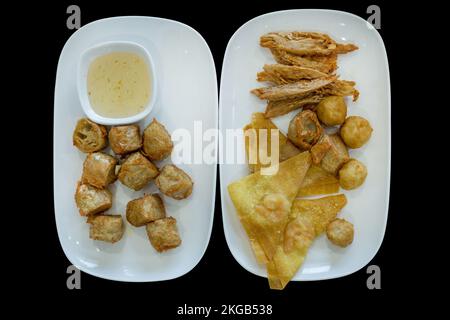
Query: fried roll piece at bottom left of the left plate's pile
[[87, 214, 124, 243]]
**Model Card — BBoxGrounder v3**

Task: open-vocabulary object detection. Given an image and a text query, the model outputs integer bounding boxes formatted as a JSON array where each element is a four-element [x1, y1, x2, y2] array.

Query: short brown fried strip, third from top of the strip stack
[[257, 63, 328, 85]]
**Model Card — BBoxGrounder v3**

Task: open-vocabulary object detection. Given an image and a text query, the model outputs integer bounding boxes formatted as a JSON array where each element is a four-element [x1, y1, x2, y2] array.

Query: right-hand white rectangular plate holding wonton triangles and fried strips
[[219, 10, 391, 280]]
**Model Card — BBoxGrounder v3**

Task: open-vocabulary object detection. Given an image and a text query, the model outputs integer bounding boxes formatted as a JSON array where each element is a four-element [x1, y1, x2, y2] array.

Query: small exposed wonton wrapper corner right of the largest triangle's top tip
[[297, 165, 339, 197]]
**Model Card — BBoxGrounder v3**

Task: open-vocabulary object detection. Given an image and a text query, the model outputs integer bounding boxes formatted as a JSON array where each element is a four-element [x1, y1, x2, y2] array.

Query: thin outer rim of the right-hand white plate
[[219, 9, 391, 281]]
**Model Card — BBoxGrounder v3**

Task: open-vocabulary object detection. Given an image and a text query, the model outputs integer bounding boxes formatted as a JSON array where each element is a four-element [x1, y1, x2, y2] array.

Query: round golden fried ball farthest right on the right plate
[[340, 116, 373, 149]]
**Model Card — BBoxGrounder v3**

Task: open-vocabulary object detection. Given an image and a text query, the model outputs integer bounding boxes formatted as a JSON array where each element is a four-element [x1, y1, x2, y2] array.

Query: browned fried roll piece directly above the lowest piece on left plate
[[127, 194, 166, 227]]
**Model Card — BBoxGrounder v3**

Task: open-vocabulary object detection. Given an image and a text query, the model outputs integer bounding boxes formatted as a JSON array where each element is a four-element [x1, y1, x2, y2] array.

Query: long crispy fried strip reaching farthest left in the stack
[[251, 76, 336, 101]]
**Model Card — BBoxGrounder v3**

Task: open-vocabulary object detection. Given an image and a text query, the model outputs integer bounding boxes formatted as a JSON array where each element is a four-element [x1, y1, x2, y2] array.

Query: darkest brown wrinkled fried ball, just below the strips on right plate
[[288, 110, 323, 150]]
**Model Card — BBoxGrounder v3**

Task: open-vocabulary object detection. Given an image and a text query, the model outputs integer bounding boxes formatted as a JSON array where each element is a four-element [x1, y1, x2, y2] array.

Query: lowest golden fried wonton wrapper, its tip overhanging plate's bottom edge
[[267, 194, 347, 290]]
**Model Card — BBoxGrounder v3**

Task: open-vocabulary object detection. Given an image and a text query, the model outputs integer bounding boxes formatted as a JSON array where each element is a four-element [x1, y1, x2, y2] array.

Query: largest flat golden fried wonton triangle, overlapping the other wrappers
[[228, 152, 311, 260]]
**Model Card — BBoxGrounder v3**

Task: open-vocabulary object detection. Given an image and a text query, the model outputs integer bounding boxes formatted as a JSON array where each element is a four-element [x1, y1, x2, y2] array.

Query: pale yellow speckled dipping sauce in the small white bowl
[[87, 52, 151, 118]]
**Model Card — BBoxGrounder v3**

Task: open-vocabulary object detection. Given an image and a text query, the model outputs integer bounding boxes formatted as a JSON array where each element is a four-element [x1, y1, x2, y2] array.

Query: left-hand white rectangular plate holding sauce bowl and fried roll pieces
[[54, 17, 218, 281]]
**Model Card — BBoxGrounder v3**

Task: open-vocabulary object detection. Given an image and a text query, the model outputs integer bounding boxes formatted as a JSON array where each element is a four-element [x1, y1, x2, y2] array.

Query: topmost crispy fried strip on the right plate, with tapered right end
[[260, 31, 358, 56]]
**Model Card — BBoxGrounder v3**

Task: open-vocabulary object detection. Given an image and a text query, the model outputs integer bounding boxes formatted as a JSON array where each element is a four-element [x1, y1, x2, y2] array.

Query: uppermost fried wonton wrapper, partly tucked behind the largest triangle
[[244, 112, 300, 172]]
